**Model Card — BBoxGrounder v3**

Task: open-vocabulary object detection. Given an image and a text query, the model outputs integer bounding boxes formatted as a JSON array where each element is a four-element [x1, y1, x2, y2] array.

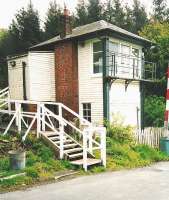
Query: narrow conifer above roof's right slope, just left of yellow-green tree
[[132, 0, 148, 33]]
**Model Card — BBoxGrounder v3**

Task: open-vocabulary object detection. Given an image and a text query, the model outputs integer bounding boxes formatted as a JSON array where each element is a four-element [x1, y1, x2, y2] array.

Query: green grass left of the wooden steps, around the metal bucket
[[0, 136, 74, 191]]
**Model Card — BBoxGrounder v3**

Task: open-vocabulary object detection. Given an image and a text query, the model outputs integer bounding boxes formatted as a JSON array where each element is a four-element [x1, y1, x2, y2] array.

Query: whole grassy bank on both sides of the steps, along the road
[[0, 124, 169, 191]]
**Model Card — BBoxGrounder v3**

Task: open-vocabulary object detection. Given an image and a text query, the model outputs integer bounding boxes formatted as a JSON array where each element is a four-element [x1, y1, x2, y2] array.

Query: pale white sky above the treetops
[[0, 0, 169, 28]]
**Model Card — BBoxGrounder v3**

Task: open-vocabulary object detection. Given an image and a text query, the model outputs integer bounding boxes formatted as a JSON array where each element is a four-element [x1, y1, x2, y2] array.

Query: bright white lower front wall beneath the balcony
[[110, 81, 141, 127]]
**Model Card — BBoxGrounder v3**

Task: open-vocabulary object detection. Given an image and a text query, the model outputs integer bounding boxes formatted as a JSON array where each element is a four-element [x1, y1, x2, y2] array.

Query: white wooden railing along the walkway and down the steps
[[0, 94, 106, 170]]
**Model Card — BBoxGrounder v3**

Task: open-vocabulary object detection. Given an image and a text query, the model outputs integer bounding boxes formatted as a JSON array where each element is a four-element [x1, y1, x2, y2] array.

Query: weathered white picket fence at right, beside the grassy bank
[[134, 127, 167, 148]]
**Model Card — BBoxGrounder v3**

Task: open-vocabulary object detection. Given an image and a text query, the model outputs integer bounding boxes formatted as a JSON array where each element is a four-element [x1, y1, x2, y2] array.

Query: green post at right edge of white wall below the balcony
[[140, 82, 145, 129]]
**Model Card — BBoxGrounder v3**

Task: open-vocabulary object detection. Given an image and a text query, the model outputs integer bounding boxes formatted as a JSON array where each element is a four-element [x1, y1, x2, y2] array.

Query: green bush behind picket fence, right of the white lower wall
[[144, 95, 165, 127]]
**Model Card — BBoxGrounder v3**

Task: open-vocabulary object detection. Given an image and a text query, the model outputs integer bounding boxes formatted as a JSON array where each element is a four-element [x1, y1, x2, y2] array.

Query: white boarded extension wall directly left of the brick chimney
[[28, 52, 55, 101]]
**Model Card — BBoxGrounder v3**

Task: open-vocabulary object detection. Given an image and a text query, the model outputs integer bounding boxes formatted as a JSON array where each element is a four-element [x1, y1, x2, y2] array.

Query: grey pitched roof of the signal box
[[30, 20, 152, 49]]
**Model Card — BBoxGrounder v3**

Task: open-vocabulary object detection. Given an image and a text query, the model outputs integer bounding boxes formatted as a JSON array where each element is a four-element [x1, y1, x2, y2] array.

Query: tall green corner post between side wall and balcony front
[[102, 38, 110, 120]]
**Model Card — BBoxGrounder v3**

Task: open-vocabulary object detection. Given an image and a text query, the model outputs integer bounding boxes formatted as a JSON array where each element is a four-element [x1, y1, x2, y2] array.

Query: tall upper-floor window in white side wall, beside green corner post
[[93, 41, 103, 74]]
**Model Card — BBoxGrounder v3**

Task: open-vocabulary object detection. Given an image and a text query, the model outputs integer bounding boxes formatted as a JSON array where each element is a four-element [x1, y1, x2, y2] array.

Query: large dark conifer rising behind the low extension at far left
[[9, 2, 42, 53]]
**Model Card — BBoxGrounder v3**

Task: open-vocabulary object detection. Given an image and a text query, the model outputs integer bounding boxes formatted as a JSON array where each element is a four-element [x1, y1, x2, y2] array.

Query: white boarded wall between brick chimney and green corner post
[[78, 40, 103, 124]]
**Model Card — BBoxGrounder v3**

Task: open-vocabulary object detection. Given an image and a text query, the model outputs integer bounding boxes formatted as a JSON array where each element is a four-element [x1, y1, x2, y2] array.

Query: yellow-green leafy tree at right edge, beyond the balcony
[[140, 21, 169, 96]]
